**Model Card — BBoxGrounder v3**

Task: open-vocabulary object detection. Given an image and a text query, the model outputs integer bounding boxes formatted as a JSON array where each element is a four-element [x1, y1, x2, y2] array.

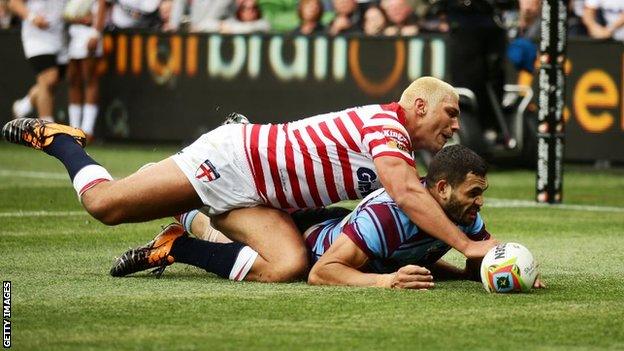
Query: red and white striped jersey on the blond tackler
[[243, 103, 414, 209]]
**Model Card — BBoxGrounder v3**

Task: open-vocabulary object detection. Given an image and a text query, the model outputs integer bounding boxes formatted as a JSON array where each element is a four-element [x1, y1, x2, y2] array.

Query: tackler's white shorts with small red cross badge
[[172, 124, 264, 215]]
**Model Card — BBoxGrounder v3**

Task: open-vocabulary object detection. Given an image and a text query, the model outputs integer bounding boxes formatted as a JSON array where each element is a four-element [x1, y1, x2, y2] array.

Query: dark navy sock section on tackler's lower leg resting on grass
[[169, 236, 245, 279]]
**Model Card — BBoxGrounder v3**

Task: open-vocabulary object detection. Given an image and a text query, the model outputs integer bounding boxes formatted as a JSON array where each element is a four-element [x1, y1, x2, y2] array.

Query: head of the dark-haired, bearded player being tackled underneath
[[426, 145, 488, 225]]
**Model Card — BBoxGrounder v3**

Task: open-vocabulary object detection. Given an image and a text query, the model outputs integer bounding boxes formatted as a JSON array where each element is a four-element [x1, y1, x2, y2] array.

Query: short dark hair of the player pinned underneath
[[426, 145, 488, 187]]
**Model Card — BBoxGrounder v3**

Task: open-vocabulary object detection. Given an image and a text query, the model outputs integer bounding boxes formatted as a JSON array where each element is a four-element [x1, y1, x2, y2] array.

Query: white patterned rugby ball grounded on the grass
[[481, 243, 537, 293]]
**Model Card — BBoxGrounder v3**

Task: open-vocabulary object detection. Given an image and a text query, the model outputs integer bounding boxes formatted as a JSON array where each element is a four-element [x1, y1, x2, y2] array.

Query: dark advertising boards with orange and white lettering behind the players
[[0, 31, 624, 162]]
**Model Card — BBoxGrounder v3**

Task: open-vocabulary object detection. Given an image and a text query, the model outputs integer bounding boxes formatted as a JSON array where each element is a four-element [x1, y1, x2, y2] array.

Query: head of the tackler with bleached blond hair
[[399, 77, 459, 153]]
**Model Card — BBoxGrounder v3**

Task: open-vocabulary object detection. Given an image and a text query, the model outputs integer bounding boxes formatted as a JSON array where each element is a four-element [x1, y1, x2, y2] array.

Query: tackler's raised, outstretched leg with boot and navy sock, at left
[[2, 119, 202, 225]]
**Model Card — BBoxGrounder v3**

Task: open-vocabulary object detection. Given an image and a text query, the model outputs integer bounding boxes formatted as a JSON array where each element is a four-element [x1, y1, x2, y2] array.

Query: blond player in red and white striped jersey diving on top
[[2, 77, 495, 282]]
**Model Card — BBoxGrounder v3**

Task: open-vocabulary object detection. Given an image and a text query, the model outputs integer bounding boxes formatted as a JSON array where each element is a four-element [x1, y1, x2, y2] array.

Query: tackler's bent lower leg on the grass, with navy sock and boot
[[110, 207, 308, 282]]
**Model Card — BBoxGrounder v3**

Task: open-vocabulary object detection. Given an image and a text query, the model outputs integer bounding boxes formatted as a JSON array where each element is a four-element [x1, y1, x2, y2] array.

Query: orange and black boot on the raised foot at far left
[[2, 118, 87, 150]]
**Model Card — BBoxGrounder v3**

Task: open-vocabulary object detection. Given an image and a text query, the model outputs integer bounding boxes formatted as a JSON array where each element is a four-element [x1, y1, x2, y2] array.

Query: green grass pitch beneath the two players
[[0, 143, 624, 350]]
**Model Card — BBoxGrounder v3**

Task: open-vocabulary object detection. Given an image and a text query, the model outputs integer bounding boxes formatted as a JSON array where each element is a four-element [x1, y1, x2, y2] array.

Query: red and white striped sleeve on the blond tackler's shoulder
[[361, 112, 414, 166]]
